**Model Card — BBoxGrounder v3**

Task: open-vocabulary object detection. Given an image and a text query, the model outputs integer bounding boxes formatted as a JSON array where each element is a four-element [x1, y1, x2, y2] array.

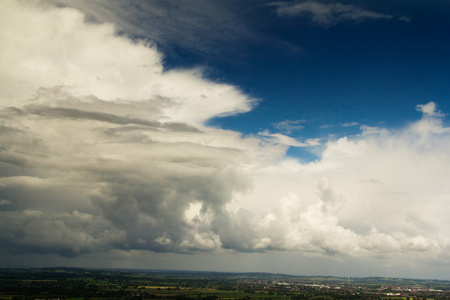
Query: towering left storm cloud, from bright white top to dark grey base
[[0, 1, 264, 256]]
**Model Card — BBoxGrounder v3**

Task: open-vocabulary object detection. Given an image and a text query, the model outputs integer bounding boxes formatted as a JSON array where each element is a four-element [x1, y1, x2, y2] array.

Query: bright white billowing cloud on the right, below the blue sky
[[230, 105, 450, 262]]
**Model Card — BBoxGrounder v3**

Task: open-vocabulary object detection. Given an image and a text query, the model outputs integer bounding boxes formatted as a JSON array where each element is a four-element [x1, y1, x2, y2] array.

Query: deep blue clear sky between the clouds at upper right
[[156, 1, 450, 136]]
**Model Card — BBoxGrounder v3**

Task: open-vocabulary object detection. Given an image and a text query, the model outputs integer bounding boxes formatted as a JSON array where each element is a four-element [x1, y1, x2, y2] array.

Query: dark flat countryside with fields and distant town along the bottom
[[0, 268, 450, 300]]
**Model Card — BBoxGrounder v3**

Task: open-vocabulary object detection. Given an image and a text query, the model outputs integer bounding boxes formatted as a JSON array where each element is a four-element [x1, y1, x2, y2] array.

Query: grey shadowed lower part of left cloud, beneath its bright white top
[[0, 107, 253, 256]]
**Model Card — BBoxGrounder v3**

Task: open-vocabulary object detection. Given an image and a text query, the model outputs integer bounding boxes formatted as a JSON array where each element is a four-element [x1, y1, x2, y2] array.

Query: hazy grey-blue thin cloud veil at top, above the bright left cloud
[[53, 0, 250, 56]]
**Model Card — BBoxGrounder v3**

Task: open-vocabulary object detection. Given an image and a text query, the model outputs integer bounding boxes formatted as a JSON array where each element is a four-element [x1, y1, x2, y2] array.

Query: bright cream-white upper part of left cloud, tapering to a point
[[0, 1, 255, 124]]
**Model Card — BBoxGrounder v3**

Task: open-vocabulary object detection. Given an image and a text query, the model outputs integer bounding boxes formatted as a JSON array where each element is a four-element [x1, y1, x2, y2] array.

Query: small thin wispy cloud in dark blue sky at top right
[[271, 1, 393, 27]]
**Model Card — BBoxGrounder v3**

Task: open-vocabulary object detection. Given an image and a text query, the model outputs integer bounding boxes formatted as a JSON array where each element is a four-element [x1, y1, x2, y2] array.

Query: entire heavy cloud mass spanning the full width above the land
[[0, 1, 450, 270]]
